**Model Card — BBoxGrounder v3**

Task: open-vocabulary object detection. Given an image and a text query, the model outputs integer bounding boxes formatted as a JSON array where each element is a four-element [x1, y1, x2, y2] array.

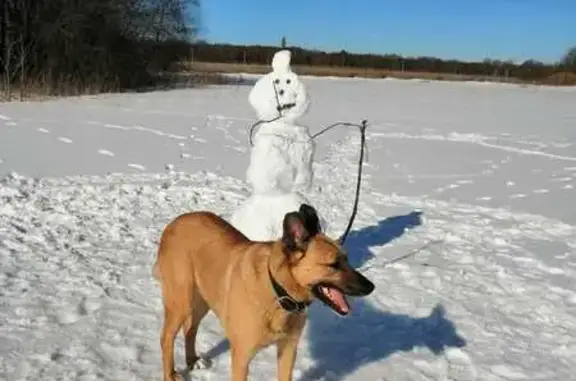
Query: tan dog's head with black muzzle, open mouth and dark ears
[[282, 204, 374, 316]]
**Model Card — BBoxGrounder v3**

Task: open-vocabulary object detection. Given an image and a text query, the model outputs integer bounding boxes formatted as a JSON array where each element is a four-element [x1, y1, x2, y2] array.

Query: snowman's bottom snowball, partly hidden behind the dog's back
[[230, 193, 324, 241]]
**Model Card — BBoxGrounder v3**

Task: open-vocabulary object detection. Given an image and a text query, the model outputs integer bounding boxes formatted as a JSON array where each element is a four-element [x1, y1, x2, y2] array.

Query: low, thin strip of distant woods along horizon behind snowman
[[193, 39, 576, 81]]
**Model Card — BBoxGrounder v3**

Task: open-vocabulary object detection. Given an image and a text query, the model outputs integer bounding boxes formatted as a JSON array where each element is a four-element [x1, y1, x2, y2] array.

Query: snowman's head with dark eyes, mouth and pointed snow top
[[248, 50, 310, 123]]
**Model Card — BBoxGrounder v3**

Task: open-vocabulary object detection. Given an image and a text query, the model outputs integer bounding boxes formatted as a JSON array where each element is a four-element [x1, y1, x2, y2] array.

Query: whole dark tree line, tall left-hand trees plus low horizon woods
[[0, 0, 576, 99]]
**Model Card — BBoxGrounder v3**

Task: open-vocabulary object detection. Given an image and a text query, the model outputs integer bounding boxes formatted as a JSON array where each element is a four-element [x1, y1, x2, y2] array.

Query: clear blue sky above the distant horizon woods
[[200, 0, 576, 62]]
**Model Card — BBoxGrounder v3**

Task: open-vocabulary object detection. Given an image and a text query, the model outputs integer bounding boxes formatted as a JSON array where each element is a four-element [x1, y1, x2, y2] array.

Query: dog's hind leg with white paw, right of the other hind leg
[[182, 290, 210, 370]]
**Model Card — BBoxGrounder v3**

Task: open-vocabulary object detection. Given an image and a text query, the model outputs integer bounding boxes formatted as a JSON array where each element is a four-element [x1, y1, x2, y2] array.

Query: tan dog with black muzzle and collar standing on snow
[[153, 205, 374, 381]]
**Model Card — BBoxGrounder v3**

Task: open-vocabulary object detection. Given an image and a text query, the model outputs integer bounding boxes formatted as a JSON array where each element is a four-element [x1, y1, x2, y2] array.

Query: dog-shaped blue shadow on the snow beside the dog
[[299, 299, 466, 381]]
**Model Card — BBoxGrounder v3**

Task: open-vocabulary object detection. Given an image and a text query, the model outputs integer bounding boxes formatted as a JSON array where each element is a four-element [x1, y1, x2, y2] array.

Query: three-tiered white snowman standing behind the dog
[[230, 50, 326, 241]]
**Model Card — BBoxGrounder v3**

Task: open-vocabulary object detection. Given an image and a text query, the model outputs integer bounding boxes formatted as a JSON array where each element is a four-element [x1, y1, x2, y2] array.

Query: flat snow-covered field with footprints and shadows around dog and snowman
[[0, 77, 576, 381]]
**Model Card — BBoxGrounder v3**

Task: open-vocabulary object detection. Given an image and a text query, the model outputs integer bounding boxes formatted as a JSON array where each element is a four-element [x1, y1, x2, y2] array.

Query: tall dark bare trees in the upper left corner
[[0, 0, 199, 97]]
